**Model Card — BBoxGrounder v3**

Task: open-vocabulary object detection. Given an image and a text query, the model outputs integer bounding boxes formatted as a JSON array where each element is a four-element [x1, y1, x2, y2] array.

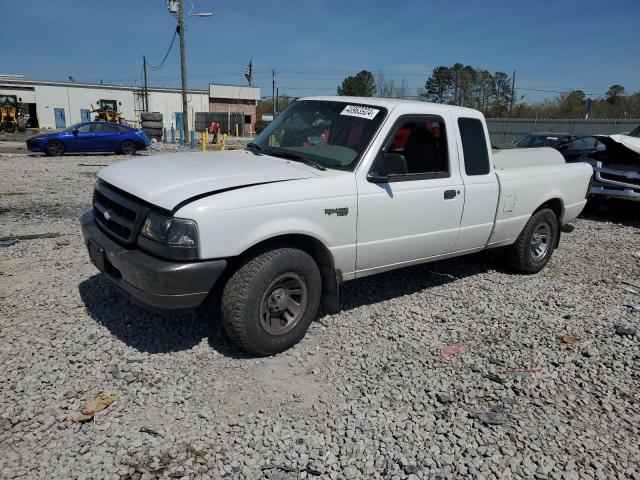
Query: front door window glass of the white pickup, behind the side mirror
[[386, 116, 449, 174]]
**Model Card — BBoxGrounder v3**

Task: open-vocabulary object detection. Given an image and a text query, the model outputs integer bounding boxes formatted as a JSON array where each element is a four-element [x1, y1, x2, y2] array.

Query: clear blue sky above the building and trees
[[0, 0, 640, 100]]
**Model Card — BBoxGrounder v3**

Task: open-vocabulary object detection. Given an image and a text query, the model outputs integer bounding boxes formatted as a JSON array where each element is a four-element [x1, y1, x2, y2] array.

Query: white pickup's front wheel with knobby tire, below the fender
[[221, 247, 322, 355]]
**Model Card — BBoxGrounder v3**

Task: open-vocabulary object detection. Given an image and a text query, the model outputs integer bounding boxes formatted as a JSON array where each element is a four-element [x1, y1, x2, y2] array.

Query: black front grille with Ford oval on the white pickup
[[93, 181, 149, 245]]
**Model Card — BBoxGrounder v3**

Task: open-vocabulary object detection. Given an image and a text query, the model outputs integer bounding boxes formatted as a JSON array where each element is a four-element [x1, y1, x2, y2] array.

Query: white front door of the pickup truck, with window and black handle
[[356, 115, 465, 277]]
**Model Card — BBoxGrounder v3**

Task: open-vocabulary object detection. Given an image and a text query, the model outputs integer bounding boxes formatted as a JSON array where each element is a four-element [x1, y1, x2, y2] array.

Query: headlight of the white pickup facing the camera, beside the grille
[[138, 212, 198, 260]]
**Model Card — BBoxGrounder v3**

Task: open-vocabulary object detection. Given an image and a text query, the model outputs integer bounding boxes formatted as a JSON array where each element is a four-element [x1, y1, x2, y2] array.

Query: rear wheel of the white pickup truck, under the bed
[[507, 208, 559, 273]]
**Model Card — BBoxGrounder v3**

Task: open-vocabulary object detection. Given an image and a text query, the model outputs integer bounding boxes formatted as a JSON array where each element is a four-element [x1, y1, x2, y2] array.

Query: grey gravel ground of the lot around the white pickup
[[0, 151, 640, 479]]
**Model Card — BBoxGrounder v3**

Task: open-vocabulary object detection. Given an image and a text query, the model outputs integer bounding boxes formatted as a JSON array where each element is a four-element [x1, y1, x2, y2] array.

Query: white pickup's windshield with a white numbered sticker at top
[[253, 100, 387, 170]]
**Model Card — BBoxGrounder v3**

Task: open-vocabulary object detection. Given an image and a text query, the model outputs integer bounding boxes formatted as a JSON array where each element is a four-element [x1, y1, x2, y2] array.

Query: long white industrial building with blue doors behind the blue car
[[0, 75, 260, 131]]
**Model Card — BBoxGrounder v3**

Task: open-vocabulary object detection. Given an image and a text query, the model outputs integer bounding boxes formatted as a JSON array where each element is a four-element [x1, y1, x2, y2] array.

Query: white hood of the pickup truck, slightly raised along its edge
[[98, 150, 319, 210]]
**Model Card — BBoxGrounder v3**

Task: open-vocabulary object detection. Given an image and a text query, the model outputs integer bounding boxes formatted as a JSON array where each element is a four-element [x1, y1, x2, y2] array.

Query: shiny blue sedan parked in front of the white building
[[27, 122, 151, 156]]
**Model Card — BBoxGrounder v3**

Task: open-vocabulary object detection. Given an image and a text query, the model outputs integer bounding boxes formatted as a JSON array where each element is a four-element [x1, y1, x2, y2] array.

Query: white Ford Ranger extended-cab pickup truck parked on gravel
[[81, 97, 592, 355]]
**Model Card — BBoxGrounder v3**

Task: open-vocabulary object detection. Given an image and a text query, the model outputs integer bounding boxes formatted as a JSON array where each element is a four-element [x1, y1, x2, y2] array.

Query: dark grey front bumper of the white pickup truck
[[80, 211, 227, 310]]
